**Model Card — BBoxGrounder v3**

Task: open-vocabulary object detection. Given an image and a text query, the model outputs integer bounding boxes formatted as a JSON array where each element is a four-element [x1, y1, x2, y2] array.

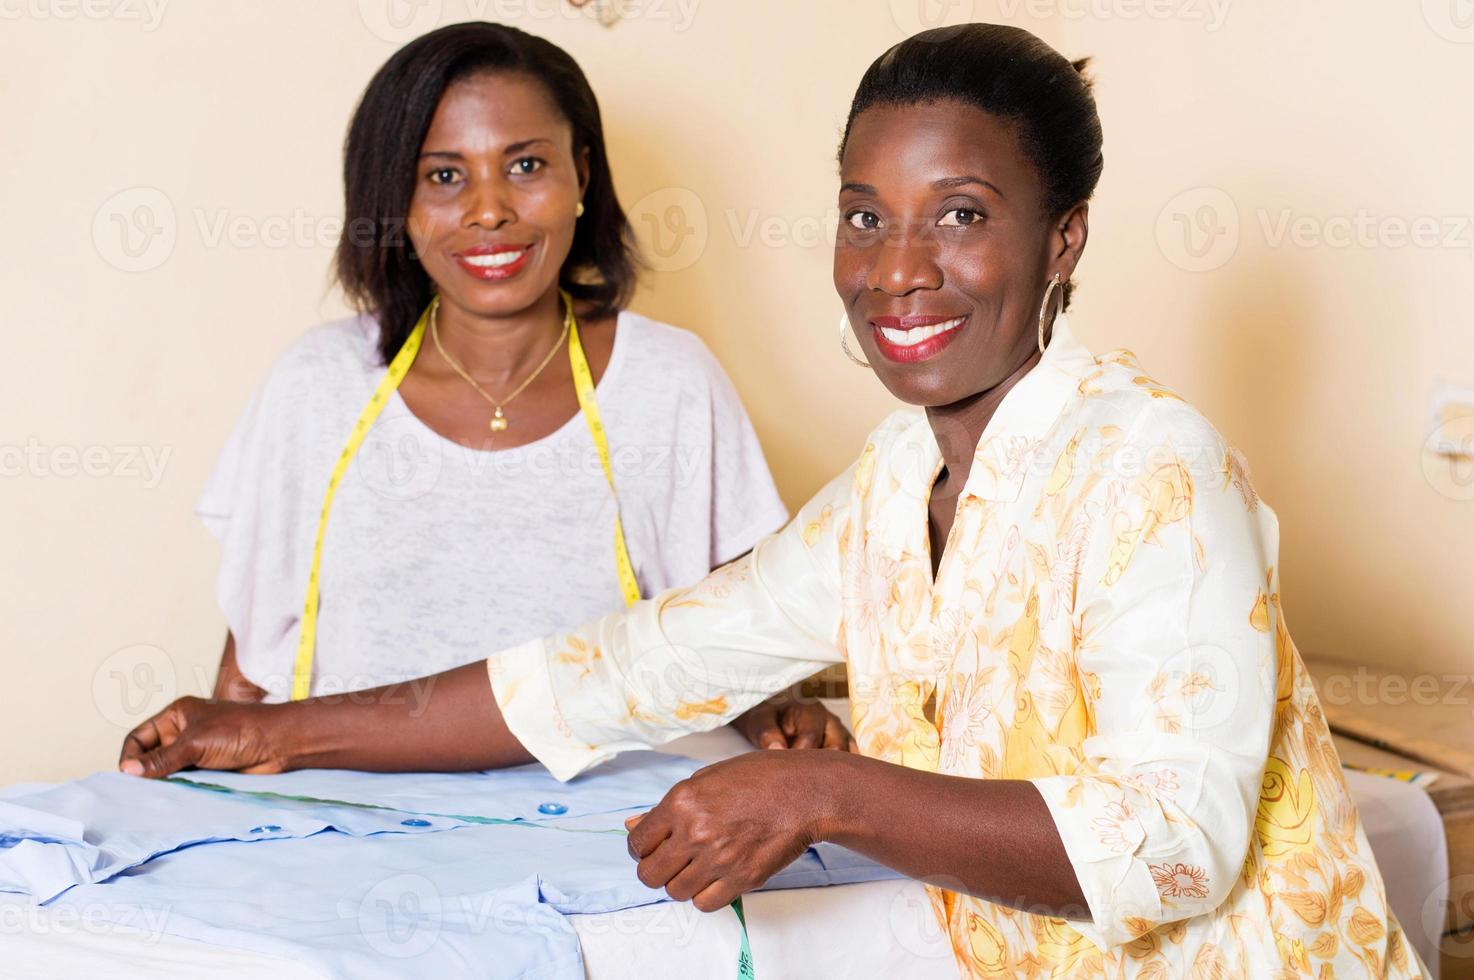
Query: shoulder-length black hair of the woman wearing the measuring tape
[[336, 21, 640, 363]]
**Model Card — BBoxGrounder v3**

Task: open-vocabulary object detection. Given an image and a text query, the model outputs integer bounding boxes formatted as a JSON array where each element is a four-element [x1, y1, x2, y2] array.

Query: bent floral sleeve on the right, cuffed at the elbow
[[1033, 424, 1278, 946]]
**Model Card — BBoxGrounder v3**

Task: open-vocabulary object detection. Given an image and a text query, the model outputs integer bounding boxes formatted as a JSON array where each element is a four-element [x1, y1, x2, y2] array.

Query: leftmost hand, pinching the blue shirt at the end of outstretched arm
[[118, 697, 289, 780]]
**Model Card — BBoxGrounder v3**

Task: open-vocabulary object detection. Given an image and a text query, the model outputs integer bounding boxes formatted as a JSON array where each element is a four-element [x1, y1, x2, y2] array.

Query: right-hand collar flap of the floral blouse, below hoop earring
[[963, 314, 1095, 501]]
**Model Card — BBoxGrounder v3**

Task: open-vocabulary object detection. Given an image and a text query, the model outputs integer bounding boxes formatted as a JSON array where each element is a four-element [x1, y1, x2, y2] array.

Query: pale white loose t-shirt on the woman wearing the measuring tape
[[198, 312, 787, 701]]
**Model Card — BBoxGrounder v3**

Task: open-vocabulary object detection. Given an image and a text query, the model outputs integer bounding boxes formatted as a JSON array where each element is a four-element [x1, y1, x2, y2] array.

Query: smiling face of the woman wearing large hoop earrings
[[834, 102, 1086, 407]]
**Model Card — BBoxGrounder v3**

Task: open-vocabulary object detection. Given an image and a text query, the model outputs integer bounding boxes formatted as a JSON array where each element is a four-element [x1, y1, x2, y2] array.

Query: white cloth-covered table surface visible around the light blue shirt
[[0, 700, 1447, 980]]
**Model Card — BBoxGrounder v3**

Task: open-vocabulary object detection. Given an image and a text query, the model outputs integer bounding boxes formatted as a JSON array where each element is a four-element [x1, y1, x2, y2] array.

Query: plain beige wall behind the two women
[[0, 0, 1474, 784]]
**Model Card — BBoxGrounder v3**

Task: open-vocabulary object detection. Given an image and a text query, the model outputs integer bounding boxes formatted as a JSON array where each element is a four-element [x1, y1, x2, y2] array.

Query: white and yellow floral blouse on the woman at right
[[488, 317, 1421, 980]]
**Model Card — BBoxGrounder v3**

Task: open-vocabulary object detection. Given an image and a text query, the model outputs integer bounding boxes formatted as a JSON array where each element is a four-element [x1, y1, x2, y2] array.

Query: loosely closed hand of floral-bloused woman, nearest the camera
[[625, 752, 845, 912]]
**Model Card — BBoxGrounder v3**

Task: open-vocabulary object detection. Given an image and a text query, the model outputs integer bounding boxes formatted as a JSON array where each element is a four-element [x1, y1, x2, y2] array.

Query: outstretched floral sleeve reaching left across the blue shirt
[[486, 472, 853, 780]]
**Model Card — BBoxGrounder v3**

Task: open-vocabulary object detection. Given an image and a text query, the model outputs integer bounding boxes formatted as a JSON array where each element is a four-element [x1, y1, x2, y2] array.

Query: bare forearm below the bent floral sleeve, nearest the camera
[[817, 753, 1089, 918]]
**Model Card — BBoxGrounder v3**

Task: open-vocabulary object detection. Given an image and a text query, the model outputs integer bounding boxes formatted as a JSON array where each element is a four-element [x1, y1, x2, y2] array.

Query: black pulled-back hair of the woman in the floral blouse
[[839, 24, 1106, 302]]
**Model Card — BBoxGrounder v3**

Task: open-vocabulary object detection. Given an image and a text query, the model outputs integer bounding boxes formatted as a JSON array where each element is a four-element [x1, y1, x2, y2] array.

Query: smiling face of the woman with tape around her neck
[[408, 74, 588, 317]]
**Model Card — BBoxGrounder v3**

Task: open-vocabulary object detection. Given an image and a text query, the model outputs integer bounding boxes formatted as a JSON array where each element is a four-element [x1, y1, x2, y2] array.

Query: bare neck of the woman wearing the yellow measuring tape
[[422, 287, 563, 392]]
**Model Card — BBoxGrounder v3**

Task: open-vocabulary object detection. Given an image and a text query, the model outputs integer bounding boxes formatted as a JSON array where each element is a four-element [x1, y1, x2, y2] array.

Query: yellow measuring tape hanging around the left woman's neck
[[292, 290, 640, 701]]
